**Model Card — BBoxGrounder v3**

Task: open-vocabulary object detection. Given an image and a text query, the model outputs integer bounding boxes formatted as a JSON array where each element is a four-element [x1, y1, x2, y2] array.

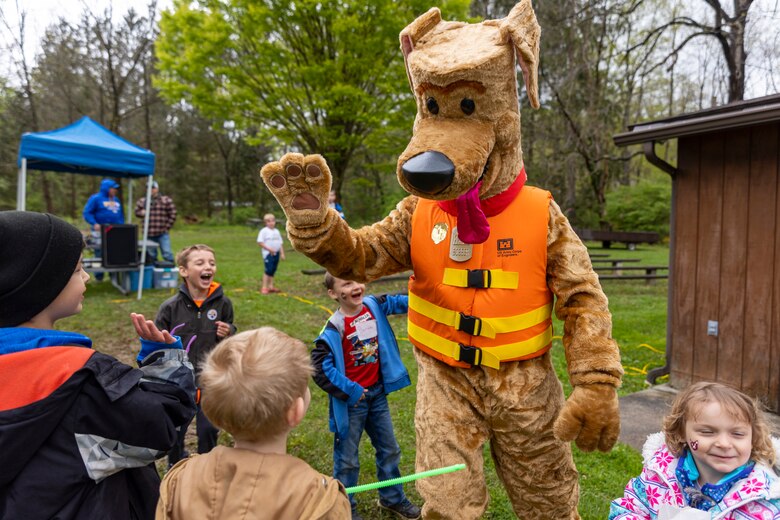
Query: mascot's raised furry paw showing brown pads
[[260, 153, 331, 228]]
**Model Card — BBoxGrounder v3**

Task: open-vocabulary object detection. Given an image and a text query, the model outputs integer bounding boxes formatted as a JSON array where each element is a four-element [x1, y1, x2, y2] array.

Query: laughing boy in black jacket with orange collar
[[155, 244, 236, 465]]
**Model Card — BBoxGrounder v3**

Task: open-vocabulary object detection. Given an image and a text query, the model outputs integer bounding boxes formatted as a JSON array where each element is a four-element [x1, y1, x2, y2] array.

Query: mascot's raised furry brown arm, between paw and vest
[[287, 196, 417, 282]]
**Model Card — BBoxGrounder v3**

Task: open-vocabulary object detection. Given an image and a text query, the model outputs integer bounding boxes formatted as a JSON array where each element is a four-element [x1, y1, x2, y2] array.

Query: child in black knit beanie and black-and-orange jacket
[[0, 211, 195, 520]]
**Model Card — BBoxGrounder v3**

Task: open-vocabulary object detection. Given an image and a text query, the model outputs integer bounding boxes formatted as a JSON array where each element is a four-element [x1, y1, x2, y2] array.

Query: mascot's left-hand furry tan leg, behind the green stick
[[414, 350, 489, 520]]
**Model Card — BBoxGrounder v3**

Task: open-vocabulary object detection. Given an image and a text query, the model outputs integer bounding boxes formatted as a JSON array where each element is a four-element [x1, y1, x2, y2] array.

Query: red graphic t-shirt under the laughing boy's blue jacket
[[341, 305, 379, 388]]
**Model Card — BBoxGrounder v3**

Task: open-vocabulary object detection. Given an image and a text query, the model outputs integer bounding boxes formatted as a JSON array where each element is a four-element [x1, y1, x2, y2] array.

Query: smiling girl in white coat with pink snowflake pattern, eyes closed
[[609, 382, 780, 520]]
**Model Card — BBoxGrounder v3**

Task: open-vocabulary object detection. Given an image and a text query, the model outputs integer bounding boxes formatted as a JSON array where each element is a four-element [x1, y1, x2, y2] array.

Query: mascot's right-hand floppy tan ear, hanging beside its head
[[500, 0, 542, 108]]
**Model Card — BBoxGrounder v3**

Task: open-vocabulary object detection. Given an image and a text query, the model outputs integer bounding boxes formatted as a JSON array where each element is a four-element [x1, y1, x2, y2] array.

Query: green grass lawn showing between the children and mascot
[[65, 226, 668, 520]]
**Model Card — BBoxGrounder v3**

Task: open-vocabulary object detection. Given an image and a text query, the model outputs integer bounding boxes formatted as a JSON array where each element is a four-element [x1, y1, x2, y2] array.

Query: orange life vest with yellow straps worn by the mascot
[[408, 186, 553, 369]]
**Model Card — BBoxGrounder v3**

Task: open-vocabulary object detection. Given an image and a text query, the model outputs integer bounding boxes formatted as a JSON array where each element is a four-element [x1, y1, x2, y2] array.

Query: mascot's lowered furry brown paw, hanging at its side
[[554, 384, 620, 451]]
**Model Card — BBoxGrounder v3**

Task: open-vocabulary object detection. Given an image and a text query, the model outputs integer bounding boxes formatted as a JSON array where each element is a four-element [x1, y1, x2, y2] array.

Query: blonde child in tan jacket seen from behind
[[156, 327, 350, 520]]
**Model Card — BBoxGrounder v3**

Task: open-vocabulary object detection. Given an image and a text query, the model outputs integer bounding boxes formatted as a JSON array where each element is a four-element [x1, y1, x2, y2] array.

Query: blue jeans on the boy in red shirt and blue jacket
[[333, 383, 406, 509]]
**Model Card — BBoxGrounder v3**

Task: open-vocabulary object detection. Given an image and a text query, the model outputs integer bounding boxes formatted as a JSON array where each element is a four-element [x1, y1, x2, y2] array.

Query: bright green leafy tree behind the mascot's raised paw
[[155, 0, 468, 199]]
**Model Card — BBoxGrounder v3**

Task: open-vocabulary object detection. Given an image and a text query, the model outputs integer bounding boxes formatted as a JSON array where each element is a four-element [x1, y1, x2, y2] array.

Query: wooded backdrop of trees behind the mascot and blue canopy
[[0, 0, 780, 234]]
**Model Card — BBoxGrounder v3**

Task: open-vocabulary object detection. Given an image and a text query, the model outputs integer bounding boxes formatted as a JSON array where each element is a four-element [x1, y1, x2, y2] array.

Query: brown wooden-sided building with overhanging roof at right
[[614, 95, 780, 412]]
